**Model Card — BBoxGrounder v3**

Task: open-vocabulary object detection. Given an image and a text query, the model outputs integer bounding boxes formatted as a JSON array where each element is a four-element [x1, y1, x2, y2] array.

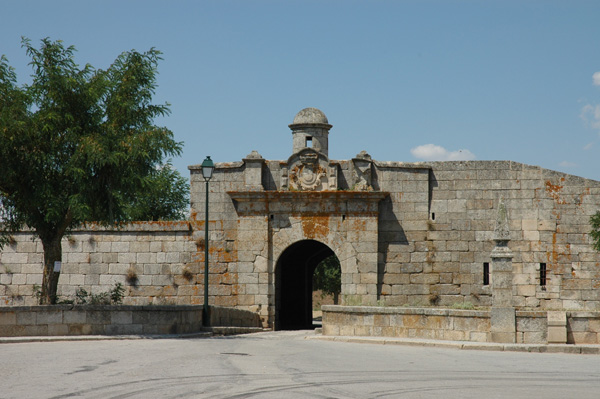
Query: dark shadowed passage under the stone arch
[[275, 240, 335, 330]]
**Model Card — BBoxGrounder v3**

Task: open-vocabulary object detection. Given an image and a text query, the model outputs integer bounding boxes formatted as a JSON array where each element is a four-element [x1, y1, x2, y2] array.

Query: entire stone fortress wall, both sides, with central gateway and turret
[[0, 108, 600, 334]]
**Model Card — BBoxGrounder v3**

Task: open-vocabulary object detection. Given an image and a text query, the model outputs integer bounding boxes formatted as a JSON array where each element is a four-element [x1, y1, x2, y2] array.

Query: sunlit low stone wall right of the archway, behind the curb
[[322, 305, 600, 344]]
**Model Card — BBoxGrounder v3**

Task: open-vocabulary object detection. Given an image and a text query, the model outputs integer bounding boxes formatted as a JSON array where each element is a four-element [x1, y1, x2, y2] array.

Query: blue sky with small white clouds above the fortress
[[0, 0, 600, 180]]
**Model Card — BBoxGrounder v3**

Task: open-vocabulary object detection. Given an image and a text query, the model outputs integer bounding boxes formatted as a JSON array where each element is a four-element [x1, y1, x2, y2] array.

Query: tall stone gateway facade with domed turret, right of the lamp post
[[190, 108, 600, 328]]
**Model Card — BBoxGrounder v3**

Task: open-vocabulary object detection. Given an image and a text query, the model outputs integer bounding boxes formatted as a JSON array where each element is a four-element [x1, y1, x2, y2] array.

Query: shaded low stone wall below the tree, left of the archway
[[0, 305, 261, 337]]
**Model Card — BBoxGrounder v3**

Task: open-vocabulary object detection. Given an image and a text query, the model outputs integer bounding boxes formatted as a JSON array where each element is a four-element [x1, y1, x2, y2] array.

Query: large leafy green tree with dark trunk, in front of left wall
[[0, 38, 182, 303]]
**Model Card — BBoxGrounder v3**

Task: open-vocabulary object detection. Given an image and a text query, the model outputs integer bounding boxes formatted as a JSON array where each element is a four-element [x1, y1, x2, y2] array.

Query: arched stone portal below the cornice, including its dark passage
[[228, 191, 384, 329]]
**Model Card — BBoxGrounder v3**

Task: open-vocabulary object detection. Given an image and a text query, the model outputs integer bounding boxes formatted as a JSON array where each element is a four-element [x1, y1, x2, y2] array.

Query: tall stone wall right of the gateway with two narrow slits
[[375, 161, 600, 310]]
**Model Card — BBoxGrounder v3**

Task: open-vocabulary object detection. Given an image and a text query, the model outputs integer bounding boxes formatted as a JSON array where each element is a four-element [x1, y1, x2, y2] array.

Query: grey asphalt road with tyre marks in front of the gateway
[[0, 332, 600, 399]]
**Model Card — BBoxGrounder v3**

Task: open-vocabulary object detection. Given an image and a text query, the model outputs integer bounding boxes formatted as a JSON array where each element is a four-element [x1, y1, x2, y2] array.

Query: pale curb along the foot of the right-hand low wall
[[306, 335, 600, 355]]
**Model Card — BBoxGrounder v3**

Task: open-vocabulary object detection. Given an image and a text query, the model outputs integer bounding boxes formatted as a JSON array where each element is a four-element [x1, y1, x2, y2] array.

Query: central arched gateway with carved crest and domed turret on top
[[218, 108, 387, 329]]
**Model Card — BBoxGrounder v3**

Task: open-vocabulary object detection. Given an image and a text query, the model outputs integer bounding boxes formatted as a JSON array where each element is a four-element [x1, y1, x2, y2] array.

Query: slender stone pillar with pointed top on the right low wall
[[490, 198, 516, 343]]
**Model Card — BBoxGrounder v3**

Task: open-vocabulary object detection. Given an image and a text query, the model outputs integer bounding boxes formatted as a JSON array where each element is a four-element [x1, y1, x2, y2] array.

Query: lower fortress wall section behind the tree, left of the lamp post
[[0, 222, 202, 306]]
